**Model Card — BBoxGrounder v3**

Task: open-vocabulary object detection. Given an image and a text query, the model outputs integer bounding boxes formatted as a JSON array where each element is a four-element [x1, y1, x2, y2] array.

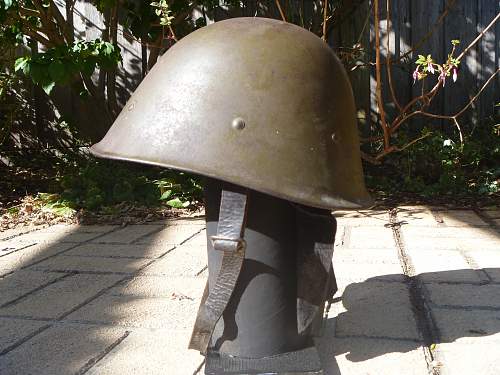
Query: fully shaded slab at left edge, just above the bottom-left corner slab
[[0, 275, 122, 319]]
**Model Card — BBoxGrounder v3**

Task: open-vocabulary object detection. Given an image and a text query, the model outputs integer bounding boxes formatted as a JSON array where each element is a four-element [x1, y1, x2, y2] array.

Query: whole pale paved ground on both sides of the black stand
[[0, 206, 500, 375]]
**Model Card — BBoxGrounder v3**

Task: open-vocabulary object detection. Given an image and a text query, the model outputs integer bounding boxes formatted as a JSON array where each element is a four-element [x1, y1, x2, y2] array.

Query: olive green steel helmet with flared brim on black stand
[[91, 18, 371, 209]]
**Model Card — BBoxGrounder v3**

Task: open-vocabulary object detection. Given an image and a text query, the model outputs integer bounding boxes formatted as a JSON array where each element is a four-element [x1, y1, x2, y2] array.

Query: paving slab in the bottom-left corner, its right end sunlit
[[0, 325, 125, 375]]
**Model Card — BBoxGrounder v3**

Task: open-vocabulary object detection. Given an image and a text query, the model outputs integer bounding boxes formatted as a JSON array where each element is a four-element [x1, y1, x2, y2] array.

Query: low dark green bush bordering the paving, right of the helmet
[[365, 120, 500, 197]]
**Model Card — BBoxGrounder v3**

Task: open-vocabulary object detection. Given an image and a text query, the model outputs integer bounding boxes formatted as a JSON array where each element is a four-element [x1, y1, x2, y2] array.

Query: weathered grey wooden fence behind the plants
[[60, 0, 500, 136]]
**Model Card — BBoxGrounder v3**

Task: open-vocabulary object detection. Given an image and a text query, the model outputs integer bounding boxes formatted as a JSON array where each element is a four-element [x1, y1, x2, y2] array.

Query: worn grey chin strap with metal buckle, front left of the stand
[[189, 190, 247, 354]]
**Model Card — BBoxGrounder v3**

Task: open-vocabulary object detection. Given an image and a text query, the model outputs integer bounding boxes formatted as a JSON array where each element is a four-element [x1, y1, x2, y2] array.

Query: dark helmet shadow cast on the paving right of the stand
[[318, 268, 500, 375]]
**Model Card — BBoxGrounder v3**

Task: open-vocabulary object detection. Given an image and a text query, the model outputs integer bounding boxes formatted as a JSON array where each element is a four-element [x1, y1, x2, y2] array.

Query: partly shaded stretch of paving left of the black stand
[[0, 219, 206, 375]]
